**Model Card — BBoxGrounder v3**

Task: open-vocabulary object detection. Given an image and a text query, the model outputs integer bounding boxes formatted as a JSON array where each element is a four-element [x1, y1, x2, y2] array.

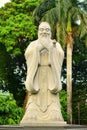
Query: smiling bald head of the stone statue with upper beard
[[38, 22, 51, 38]]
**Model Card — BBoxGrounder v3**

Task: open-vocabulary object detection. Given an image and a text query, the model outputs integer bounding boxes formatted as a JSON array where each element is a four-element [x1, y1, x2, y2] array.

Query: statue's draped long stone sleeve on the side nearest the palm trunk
[[50, 43, 64, 93]]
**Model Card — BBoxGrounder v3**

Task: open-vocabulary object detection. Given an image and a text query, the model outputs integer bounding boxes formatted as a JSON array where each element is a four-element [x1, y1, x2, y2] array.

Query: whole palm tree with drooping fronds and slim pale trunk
[[33, 0, 87, 123]]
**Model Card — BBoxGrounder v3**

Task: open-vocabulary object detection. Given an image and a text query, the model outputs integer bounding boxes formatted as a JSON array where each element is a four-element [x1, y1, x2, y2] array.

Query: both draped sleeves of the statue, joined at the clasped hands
[[25, 40, 64, 93]]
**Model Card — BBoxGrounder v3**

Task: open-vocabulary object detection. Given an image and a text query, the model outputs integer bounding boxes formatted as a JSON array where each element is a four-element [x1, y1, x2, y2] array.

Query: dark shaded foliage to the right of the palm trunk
[[72, 38, 87, 124]]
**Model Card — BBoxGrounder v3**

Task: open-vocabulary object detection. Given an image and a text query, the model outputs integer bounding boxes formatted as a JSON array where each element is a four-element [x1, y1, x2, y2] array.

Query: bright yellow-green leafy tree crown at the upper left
[[0, 0, 44, 55]]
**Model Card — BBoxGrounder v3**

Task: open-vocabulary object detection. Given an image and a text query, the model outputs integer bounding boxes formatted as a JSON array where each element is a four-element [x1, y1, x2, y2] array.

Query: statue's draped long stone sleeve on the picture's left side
[[25, 41, 39, 93]]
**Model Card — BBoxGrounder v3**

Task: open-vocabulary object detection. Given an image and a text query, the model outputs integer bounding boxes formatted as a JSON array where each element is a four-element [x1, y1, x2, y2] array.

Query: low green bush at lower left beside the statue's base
[[0, 93, 24, 125]]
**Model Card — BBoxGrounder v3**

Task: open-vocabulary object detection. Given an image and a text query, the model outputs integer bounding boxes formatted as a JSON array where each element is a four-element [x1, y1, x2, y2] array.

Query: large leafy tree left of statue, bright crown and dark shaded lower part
[[0, 0, 40, 105]]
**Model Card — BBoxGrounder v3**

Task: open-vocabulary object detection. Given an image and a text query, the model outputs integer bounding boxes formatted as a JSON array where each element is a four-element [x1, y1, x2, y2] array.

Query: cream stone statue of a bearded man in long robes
[[21, 22, 64, 124]]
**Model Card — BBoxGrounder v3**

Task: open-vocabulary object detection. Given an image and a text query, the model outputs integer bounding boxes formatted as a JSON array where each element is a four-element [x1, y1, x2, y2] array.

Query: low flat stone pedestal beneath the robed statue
[[0, 123, 87, 130]]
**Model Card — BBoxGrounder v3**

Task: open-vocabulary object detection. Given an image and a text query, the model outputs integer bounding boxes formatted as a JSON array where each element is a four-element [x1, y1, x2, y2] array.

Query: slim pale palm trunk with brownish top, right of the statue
[[67, 32, 73, 124]]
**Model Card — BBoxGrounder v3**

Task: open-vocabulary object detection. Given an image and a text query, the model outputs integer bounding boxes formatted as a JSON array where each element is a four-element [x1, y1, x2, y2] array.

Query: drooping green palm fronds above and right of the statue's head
[[34, 0, 87, 47]]
